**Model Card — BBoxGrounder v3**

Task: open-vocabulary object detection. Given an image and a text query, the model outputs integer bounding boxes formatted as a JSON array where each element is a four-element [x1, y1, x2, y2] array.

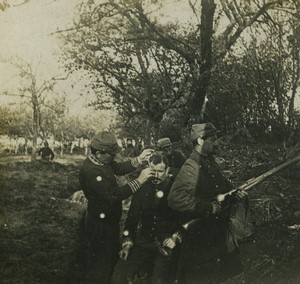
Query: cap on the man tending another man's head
[[91, 131, 121, 154]]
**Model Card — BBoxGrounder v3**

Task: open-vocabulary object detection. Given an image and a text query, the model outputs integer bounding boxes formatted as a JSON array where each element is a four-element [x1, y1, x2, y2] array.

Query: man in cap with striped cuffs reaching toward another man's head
[[79, 131, 153, 283]]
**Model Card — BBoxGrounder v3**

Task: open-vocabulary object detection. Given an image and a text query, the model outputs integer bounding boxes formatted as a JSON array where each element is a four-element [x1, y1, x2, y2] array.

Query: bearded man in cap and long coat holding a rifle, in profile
[[168, 123, 246, 284]]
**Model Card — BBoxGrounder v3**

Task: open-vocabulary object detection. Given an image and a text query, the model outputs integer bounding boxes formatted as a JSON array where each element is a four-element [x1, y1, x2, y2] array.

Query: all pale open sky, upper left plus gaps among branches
[[0, 0, 300, 113]]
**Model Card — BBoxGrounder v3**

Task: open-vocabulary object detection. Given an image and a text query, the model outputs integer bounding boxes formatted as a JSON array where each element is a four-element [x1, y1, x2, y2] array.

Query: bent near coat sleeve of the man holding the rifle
[[168, 160, 212, 215]]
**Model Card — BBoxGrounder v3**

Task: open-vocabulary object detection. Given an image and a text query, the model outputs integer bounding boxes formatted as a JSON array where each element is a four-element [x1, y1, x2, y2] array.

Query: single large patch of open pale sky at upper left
[[0, 0, 79, 80]]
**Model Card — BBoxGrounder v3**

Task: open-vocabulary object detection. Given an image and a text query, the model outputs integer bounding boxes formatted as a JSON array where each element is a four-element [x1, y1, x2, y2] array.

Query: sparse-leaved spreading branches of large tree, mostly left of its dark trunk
[[63, 0, 284, 142]]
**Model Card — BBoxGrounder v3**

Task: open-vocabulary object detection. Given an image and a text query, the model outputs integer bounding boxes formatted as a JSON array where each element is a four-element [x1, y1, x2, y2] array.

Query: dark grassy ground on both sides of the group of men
[[0, 141, 300, 283]]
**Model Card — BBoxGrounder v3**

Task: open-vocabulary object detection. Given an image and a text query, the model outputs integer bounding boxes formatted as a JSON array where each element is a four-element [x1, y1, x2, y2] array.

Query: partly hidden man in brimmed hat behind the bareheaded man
[[157, 137, 186, 177]]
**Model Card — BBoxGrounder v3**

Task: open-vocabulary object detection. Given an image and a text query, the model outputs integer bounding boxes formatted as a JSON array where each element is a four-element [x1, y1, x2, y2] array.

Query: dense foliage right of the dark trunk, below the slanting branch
[[208, 1, 300, 144]]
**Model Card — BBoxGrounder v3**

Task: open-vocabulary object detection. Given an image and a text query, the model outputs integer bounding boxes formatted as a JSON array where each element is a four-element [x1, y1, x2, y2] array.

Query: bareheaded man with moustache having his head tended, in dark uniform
[[112, 153, 178, 284]]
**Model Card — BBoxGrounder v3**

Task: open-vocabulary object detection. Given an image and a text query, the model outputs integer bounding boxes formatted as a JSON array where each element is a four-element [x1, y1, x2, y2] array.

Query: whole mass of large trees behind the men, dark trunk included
[[61, 0, 300, 145]]
